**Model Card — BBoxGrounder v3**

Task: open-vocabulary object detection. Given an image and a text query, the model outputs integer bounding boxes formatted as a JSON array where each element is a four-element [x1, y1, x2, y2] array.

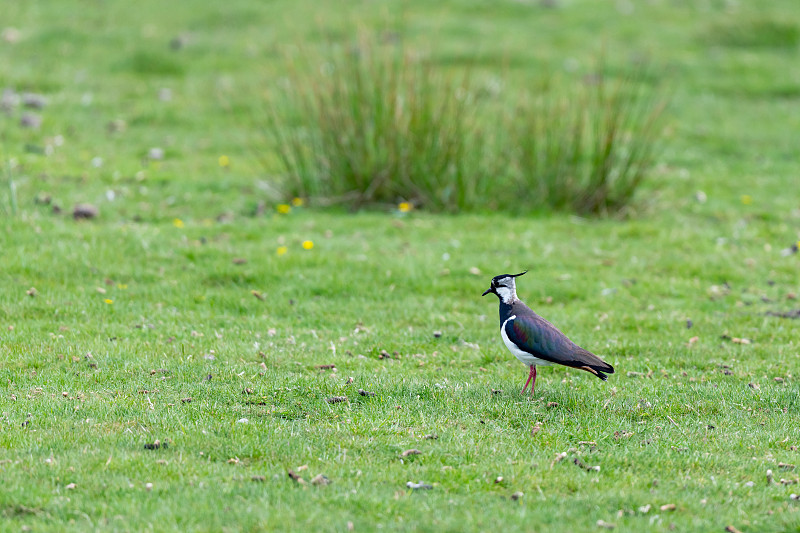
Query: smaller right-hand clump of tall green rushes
[[508, 68, 664, 215]]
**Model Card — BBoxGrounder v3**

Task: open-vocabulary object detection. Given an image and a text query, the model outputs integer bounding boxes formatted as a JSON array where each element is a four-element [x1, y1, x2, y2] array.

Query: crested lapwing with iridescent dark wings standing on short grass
[[482, 270, 614, 396]]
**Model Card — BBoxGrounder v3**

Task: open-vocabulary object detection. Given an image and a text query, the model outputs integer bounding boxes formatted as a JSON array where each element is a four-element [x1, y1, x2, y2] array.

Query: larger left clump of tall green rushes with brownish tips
[[266, 40, 482, 211]]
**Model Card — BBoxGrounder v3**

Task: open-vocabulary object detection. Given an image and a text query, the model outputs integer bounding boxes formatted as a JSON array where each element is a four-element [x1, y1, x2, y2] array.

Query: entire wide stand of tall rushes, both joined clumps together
[[265, 35, 663, 215]]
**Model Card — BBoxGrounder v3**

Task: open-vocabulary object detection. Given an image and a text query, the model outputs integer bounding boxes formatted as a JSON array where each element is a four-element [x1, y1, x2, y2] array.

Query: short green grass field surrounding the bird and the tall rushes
[[0, 0, 800, 532]]
